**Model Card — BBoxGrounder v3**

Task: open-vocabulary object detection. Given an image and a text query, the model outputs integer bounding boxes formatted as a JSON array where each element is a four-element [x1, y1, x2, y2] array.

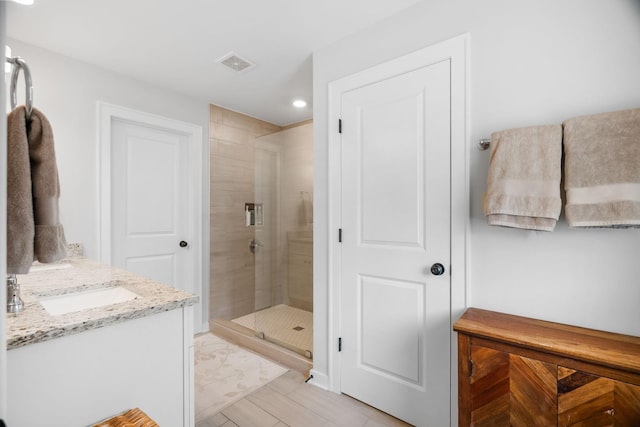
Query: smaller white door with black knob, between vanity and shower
[[111, 120, 194, 292]]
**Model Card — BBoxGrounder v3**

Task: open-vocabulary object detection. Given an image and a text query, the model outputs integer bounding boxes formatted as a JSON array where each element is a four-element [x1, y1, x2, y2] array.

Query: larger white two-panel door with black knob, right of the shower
[[339, 60, 451, 426]]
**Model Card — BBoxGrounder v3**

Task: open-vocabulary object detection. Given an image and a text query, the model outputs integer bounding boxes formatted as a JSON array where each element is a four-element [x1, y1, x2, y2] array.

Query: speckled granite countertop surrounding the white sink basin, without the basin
[[7, 257, 198, 350]]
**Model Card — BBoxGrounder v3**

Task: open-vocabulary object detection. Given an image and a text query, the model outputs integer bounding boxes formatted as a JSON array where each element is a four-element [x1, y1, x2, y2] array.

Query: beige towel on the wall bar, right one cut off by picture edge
[[563, 109, 640, 227]]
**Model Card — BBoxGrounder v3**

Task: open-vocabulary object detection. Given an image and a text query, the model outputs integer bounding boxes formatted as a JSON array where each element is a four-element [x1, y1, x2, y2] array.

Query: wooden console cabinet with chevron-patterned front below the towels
[[453, 308, 640, 427]]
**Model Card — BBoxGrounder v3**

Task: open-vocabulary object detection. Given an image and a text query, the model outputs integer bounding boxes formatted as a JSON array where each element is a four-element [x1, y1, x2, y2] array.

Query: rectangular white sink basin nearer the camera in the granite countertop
[[38, 286, 138, 316]]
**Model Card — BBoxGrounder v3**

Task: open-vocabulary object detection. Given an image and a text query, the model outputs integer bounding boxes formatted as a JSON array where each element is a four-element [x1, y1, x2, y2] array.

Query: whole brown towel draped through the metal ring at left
[[7, 106, 67, 274]]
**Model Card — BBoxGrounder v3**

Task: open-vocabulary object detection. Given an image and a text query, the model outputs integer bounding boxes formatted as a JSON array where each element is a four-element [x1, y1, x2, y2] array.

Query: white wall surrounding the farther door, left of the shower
[[7, 39, 209, 328]]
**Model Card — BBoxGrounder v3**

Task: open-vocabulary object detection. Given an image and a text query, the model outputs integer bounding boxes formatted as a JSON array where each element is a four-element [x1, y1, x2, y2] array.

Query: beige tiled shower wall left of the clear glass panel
[[209, 105, 281, 320]]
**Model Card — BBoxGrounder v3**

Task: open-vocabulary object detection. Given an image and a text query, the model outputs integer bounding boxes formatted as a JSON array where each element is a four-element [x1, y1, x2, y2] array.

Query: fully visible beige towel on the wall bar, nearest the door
[[483, 125, 562, 231]]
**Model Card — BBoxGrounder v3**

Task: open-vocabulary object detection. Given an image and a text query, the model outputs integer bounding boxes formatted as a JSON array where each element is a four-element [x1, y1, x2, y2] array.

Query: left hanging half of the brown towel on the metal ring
[[7, 106, 35, 274]]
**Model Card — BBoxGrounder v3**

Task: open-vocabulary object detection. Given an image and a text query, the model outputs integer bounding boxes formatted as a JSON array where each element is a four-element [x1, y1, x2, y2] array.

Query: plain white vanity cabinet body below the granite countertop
[[6, 307, 194, 427]]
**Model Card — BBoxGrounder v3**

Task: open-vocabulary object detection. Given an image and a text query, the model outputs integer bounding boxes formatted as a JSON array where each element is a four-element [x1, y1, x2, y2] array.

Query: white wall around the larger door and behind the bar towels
[[313, 0, 640, 384]]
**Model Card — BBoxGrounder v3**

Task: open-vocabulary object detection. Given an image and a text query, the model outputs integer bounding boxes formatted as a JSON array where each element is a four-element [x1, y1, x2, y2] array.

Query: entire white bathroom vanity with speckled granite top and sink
[[6, 257, 198, 427]]
